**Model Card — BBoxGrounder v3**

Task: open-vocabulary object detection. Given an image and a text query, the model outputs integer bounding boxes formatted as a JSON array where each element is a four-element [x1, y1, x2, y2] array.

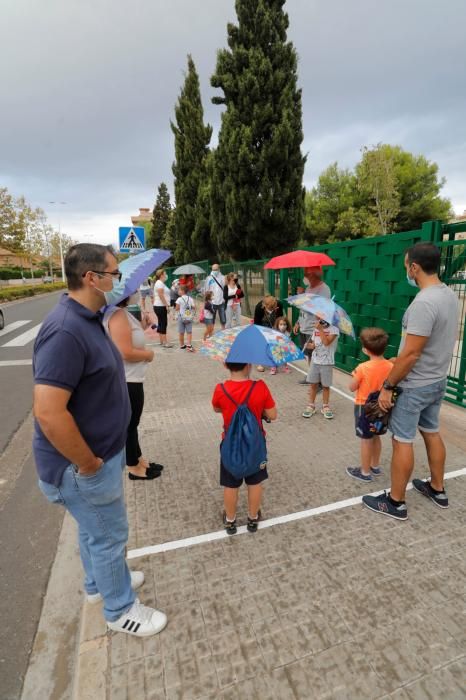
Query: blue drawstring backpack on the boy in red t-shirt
[[220, 382, 267, 479]]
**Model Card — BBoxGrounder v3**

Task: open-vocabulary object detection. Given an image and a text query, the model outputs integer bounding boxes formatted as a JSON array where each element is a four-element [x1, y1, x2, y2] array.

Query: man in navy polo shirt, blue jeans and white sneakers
[[33, 243, 167, 637]]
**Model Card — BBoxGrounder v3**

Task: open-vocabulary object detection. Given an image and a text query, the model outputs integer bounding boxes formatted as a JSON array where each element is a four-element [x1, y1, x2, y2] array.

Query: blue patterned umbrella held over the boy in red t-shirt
[[200, 325, 304, 367]]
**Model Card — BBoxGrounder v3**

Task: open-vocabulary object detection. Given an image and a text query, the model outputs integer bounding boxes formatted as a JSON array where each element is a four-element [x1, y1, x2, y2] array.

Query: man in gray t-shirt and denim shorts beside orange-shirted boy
[[363, 243, 458, 520]]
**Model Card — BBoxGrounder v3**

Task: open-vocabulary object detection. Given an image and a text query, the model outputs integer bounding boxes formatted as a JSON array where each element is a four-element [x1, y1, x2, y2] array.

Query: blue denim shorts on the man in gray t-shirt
[[388, 379, 447, 443]]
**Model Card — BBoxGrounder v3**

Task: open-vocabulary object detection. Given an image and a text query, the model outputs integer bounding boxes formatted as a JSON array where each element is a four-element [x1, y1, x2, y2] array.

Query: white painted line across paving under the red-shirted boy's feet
[[126, 468, 466, 559]]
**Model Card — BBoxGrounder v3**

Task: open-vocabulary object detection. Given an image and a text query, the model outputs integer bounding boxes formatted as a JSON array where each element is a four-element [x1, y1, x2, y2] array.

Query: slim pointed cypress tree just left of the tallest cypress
[[171, 56, 212, 262]]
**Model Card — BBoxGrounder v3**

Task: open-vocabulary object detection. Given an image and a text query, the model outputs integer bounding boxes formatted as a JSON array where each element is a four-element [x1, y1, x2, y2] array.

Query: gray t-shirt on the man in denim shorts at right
[[399, 284, 459, 389]]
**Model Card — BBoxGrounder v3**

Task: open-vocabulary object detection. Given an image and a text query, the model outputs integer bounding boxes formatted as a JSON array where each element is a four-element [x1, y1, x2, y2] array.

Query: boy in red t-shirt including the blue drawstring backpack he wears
[[212, 362, 277, 535]]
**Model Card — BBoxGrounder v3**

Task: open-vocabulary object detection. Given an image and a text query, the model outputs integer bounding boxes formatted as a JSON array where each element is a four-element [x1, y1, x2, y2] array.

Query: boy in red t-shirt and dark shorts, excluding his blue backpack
[[212, 362, 277, 535]]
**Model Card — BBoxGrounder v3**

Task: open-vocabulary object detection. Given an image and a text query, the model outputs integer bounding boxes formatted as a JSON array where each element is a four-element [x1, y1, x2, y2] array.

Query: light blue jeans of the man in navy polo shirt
[[39, 450, 136, 622]]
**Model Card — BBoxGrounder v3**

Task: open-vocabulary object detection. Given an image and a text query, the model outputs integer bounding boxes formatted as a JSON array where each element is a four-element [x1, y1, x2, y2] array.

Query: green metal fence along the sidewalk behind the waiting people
[[162, 221, 466, 408]]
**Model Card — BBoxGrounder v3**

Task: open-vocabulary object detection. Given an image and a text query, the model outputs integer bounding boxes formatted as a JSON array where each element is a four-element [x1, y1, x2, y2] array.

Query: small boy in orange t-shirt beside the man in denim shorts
[[346, 328, 393, 481]]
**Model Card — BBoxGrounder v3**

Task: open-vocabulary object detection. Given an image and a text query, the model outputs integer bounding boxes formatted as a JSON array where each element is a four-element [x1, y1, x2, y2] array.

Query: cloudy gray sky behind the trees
[[0, 0, 466, 242]]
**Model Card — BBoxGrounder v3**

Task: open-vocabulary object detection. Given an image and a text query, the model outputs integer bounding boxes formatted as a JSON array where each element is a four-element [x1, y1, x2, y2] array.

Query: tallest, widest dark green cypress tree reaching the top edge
[[211, 0, 305, 260]]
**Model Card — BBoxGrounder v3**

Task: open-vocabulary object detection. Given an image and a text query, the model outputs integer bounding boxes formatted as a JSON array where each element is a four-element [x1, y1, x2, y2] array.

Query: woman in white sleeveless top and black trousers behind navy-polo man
[[103, 295, 163, 481]]
